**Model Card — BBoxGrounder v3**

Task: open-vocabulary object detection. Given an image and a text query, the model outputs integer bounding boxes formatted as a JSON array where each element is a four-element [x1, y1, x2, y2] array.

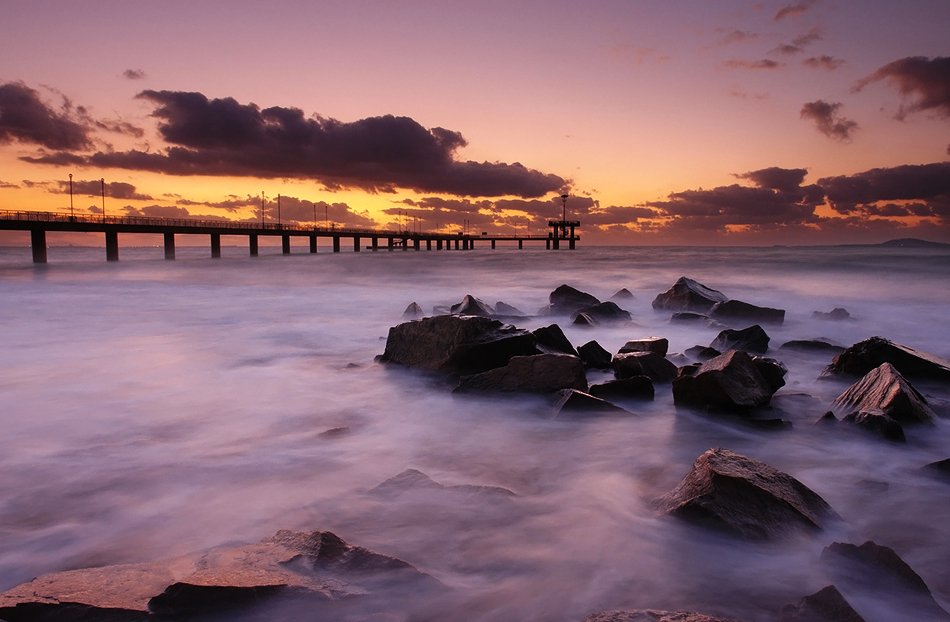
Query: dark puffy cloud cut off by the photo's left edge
[[0, 82, 92, 150]]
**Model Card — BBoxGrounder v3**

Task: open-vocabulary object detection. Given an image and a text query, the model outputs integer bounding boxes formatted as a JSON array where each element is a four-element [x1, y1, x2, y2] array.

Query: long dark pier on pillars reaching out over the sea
[[0, 210, 580, 263]]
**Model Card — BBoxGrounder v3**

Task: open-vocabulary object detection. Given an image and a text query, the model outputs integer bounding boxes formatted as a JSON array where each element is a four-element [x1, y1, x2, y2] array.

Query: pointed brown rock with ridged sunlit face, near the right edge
[[834, 363, 935, 423]]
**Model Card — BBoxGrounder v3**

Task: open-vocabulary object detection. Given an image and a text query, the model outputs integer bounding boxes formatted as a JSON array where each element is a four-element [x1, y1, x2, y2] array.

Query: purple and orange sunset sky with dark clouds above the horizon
[[0, 0, 950, 245]]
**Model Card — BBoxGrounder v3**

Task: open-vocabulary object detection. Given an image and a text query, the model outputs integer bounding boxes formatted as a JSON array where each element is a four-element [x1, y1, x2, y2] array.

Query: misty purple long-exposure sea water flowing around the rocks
[[0, 246, 950, 622]]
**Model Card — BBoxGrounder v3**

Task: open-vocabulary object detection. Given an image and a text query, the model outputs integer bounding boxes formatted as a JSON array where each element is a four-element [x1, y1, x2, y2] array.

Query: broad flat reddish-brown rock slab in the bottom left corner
[[0, 531, 440, 622]]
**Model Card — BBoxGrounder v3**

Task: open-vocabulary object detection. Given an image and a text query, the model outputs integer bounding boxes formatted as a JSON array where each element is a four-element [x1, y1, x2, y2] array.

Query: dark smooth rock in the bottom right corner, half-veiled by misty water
[[821, 540, 950, 620]]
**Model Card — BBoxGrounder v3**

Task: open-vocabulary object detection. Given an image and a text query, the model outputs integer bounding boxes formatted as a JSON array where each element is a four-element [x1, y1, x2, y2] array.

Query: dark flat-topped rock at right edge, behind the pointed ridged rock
[[825, 337, 950, 382]]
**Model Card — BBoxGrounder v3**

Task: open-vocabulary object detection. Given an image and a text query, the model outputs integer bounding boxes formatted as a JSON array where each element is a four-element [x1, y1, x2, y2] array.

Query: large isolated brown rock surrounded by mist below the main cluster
[[659, 448, 837, 540]]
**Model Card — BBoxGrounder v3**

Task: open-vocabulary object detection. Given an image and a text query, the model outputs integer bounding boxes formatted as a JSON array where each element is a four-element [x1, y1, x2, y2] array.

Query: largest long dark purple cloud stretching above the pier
[[28, 91, 565, 197]]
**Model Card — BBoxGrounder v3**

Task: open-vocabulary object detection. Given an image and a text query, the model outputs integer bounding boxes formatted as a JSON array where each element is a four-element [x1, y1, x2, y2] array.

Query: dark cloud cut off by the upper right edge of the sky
[[854, 56, 950, 119]]
